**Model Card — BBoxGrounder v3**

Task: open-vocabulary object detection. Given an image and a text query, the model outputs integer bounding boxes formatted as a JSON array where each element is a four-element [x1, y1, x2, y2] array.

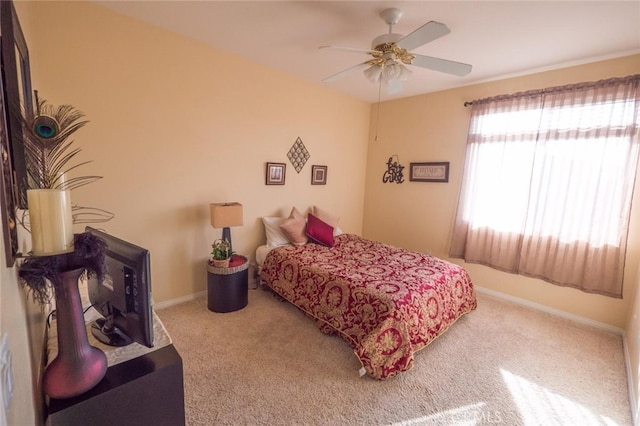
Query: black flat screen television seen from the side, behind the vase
[[85, 226, 153, 347]]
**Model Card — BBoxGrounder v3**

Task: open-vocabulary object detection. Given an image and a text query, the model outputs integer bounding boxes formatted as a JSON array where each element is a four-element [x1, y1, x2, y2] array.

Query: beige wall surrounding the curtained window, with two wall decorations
[[363, 55, 640, 328]]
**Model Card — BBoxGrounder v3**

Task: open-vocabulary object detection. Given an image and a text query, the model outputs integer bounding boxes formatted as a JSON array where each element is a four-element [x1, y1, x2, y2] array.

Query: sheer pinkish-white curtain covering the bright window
[[449, 75, 640, 298]]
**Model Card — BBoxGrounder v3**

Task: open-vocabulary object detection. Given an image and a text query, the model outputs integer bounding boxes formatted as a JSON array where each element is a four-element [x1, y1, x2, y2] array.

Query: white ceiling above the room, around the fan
[[97, 0, 640, 102]]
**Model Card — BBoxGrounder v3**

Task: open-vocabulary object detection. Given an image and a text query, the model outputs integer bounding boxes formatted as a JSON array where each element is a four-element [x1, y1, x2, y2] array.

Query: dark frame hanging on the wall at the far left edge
[[0, 0, 33, 267]]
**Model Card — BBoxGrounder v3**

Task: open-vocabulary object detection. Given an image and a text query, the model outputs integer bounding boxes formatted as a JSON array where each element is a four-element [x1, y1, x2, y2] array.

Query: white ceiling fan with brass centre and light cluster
[[320, 8, 471, 93]]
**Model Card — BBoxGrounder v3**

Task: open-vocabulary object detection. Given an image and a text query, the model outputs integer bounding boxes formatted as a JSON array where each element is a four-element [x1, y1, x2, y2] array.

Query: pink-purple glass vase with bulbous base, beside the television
[[42, 269, 107, 399]]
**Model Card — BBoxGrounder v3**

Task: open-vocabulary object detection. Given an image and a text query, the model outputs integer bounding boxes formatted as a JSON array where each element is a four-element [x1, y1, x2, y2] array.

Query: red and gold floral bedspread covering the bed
[[260, 234, 477, 379]]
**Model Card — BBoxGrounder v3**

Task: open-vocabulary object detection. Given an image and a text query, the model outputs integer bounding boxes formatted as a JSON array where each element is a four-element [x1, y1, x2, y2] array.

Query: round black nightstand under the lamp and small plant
[[207, 254, 249, 312]]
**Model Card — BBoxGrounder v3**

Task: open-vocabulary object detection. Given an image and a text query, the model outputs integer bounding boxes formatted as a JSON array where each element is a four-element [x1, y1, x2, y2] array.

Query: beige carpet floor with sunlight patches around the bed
[[158, 290, 632, 426]]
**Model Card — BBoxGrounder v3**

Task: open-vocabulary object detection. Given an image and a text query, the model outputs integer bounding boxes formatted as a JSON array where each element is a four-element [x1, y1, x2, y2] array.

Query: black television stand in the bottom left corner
[[45, 314, 185, 426]]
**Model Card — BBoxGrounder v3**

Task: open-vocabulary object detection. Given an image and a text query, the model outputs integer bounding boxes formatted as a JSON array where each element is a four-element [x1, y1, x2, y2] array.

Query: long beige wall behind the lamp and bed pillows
[[20, 2, 369, 303]]
